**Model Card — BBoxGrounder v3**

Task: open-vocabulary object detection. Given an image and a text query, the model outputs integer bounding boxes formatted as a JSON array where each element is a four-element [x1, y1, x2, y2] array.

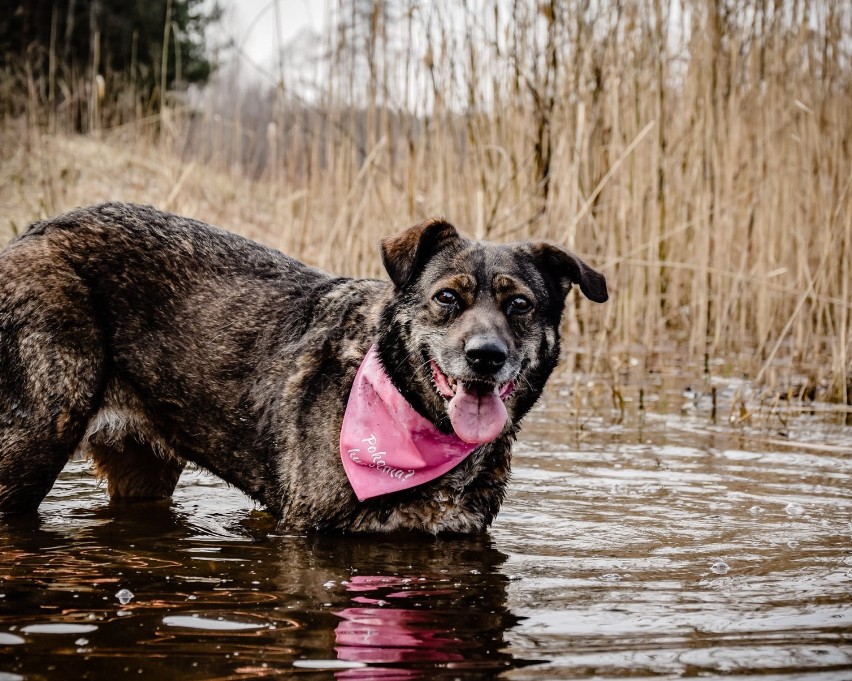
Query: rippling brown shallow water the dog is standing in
[[0, 374, 852, 681]]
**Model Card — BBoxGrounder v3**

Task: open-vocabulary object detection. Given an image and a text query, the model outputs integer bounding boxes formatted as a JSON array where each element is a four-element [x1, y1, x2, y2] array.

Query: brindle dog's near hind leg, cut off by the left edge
[[0, 238, 104, 513]]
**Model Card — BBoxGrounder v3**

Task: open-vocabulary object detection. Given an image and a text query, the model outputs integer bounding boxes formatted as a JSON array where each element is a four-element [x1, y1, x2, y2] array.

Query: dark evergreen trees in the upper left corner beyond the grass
[[0, 0, 221, 129]]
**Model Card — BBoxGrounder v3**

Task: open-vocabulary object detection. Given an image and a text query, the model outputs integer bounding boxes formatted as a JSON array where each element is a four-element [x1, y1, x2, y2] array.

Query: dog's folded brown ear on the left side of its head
[[381, 219, 461, 288]]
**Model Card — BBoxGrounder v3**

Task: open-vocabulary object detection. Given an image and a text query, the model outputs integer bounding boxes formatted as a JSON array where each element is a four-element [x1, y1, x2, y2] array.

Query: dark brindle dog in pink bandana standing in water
[[0, 203, 608, 534]]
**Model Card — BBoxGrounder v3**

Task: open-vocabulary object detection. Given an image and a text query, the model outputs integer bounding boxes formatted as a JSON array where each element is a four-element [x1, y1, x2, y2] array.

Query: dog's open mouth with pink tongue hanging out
[[432, 359, 515, 444]]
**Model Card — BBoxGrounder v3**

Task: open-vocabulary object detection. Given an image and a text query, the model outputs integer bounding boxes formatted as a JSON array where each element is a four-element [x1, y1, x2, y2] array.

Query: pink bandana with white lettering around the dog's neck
[[340, 346, 479, 501]]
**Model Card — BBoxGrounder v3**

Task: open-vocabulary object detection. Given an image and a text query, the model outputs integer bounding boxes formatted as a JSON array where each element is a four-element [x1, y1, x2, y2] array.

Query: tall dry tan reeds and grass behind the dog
[[0, 0, 852, 403]]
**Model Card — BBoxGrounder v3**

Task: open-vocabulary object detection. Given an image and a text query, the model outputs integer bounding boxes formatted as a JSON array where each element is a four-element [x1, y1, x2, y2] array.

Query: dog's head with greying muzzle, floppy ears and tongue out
[[379, 215, 607, 443]]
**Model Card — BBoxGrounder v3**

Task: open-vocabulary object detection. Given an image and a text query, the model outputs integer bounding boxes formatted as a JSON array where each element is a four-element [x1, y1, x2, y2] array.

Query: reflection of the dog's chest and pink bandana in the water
[[292, 536, 529, 679]]
